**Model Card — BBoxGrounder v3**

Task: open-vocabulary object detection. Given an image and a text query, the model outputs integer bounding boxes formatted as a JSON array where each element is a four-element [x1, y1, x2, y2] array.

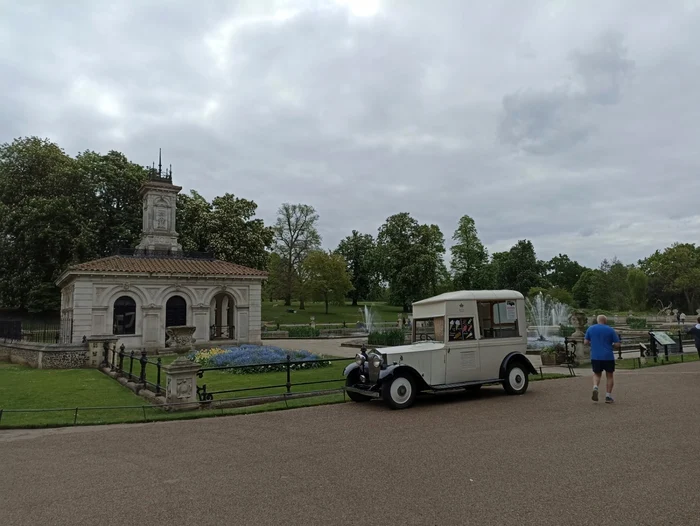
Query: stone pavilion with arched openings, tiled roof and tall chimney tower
[[56, 160, 267, 350]]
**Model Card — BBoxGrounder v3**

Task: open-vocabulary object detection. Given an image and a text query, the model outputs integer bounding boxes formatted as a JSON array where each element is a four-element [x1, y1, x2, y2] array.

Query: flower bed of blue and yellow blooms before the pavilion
[[188, 345, 331, 374]]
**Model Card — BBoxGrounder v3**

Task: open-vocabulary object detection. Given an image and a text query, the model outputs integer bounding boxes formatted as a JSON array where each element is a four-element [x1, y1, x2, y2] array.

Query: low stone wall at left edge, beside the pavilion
[[0, 342, 89, 369]]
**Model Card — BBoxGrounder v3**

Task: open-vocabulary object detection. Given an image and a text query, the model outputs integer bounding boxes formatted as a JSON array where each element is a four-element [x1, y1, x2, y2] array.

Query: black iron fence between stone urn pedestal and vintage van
[[197, 355, 355, 402]]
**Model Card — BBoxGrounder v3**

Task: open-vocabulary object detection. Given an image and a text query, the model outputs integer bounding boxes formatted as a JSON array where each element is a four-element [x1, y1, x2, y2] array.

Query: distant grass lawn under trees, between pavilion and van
[[262, 300, 402, 327]]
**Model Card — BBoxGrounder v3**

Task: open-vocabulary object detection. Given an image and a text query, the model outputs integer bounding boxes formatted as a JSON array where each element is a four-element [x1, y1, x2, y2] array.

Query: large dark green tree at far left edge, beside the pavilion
[[0, 137, 93, 312]]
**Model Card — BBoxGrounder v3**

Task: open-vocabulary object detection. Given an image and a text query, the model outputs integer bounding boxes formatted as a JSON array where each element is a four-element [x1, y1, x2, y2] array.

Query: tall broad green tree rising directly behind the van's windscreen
[[377, 212, 445, 312]]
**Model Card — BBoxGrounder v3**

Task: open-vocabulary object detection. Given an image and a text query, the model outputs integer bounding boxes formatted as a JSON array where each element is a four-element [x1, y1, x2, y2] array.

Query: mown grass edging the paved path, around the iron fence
[[0, 356, 568, 428]]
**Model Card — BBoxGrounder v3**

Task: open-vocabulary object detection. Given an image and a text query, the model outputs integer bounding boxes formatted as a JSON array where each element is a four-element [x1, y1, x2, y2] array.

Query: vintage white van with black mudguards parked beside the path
[[344, 290, 537, 409]]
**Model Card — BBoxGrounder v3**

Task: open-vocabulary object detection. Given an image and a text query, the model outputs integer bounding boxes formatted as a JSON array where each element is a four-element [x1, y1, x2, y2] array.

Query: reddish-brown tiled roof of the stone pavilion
[[68, 256, 267, 277]]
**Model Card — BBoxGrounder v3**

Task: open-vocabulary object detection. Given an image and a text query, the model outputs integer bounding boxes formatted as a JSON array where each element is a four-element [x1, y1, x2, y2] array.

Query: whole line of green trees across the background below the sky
[[0, 137, 700, 313]]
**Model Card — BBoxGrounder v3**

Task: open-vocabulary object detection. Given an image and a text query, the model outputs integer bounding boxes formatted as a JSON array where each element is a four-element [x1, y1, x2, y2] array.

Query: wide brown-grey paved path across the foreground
[[0, 363, 700, 526]]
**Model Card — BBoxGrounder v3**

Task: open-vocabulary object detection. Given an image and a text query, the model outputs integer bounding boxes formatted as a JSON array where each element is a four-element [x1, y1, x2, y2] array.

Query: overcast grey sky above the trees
[[0, 0, 700, 266]]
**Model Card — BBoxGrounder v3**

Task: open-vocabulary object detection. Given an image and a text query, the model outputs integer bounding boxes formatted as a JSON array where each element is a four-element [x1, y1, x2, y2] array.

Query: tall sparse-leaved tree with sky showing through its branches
[[274, 203, 321, 310]]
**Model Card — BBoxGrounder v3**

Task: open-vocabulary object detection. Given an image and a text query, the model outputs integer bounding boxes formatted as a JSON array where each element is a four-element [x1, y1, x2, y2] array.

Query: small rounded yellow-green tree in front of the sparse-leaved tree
[[303, 250, 352, 314]]
